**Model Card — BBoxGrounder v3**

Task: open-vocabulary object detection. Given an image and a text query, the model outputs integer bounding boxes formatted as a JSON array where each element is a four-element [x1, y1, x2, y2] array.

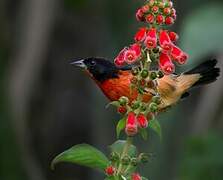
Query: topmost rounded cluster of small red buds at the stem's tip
[[136, 0, 177, 25]]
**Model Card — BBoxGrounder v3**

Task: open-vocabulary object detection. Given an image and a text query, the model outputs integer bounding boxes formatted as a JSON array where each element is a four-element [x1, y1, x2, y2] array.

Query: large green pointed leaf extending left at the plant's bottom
[[51, 144, 109, 170]]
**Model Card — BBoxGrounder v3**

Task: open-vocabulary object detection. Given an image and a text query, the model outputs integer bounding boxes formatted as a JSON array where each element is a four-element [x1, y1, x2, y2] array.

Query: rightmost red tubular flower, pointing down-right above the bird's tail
[[171, 46, 188, 64]]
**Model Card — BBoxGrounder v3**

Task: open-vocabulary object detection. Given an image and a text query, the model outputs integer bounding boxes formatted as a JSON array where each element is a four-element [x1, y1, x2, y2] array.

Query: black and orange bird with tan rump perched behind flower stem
[[71, 57, 220, 111]]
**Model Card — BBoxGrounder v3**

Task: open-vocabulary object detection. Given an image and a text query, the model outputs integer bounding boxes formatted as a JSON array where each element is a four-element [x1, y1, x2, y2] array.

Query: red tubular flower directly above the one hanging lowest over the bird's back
[[159, 30, 173, 53]]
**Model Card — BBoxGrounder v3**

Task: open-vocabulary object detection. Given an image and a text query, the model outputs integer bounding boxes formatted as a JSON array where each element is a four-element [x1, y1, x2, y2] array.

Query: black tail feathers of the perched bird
[[185, 59, 220, 86]]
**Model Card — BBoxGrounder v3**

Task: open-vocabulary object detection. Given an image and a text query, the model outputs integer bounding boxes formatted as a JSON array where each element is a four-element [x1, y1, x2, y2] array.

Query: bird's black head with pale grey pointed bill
[[71, 58, 119, 82]]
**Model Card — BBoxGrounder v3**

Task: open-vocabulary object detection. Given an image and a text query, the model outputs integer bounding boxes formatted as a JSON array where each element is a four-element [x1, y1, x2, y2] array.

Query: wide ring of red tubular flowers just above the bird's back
[[114, 27, 188, 74]]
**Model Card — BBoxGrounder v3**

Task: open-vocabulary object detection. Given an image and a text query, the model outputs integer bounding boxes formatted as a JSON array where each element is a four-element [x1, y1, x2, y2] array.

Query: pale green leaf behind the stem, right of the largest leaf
[[110, 140, 137, 157]]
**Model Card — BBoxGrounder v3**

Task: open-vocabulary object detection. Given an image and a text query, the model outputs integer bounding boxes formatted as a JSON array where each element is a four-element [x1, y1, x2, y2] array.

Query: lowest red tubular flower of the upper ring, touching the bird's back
[[159, 53, 175, 75]]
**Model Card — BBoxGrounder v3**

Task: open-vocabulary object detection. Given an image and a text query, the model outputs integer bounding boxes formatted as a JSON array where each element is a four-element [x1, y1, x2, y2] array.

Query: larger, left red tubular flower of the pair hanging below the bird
[[125, 112, 138, 136]]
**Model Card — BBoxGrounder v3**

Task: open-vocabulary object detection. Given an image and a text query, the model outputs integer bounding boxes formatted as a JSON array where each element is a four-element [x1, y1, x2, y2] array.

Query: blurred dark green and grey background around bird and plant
[[0, 0, 223, 180]]
